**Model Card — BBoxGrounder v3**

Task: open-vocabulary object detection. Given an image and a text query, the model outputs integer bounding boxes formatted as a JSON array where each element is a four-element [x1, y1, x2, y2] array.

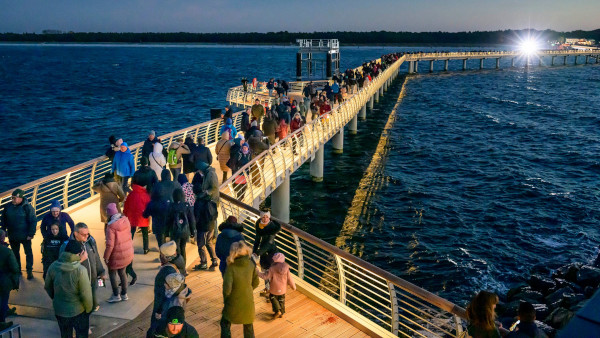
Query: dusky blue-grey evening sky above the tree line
[[0, 0, 600, 33]]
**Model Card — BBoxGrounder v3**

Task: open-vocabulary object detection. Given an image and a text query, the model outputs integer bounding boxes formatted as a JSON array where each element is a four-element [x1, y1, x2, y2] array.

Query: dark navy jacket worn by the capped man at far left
[[0, 198, 37, 241]]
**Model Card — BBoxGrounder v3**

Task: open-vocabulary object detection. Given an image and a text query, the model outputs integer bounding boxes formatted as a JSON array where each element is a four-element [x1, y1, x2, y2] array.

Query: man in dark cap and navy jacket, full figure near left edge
[[0, 189, 37, 279]]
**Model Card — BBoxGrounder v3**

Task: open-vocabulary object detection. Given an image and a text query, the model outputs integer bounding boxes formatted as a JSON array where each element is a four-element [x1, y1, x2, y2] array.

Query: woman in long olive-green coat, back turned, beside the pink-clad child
[[220, 241, 259, 338]]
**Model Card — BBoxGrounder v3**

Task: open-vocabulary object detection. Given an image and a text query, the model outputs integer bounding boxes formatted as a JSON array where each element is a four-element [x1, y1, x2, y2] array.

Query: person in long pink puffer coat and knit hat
[[104, 203, 133, 303]]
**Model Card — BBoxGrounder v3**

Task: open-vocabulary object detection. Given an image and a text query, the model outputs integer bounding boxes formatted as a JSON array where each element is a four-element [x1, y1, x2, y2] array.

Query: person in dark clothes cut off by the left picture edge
[[0, 230, 21, 331]]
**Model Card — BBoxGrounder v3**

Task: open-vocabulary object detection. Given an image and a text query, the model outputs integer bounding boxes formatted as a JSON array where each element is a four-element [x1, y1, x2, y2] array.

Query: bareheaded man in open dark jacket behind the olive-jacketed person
[[60, 223, 107, 311]]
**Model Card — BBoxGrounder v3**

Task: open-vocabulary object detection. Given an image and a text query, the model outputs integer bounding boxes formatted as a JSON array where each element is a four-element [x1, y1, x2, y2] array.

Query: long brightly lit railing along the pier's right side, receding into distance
[[220, 57, 404, 205]]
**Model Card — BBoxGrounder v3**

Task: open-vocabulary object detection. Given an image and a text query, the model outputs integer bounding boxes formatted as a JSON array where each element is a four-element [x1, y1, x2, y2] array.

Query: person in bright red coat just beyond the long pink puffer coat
[[123, 184, 150, 255]]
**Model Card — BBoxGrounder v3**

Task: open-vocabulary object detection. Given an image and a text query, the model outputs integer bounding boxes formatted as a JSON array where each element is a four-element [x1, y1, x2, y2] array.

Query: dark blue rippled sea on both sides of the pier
[[0, 45, 600, 304]]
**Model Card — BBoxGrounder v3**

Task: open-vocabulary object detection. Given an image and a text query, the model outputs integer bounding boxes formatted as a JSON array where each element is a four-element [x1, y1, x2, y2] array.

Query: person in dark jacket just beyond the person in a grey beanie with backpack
[[167, 189, 196, 266]]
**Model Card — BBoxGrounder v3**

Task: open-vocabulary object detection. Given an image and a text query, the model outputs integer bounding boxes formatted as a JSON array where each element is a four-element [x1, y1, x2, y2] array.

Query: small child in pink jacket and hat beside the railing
[[258, 252, 296, 318]]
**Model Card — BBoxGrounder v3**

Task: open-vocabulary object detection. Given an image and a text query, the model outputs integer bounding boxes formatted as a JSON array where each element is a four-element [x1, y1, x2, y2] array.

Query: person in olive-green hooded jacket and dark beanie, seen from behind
[[44, 241, 93, 337]]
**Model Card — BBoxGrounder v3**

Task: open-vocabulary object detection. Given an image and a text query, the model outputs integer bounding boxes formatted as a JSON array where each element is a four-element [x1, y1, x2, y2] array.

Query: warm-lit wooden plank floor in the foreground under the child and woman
[[107, 262, 368, 337]]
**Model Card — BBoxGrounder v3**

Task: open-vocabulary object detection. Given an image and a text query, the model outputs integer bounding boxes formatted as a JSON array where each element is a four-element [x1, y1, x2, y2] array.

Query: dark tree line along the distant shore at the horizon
[[0, 29, 600, 45]]
